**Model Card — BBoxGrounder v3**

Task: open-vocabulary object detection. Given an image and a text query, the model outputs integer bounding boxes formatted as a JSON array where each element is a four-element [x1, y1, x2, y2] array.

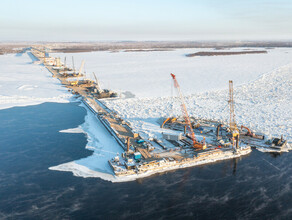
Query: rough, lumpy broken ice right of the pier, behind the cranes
[[103, 64, 292, 140]]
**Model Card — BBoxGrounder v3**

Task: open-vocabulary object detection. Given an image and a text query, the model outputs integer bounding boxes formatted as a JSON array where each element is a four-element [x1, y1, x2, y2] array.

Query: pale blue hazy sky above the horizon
[[0, 0, 292, 41]]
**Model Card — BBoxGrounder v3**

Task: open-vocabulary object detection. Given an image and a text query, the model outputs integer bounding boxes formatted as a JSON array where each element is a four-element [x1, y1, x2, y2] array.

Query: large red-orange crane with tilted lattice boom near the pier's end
[[170, 73, 206, 149]]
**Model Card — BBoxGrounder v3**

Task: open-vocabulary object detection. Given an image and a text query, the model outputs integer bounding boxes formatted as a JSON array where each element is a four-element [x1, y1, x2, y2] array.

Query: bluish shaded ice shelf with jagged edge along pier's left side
[[49, 104, 123, 182]]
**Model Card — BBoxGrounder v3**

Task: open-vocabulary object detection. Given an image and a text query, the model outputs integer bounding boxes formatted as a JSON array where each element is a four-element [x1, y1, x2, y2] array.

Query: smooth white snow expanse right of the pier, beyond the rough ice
[[52, 48, 292, 98]]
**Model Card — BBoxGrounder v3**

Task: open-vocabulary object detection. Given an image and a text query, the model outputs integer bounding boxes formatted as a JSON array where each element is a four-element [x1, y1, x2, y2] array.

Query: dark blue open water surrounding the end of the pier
[[0, 103, 292, 219]]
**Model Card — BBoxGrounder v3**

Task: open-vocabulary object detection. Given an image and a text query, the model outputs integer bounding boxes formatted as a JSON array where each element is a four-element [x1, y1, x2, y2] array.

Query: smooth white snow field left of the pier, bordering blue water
[[0, 53, 72, 109]]
